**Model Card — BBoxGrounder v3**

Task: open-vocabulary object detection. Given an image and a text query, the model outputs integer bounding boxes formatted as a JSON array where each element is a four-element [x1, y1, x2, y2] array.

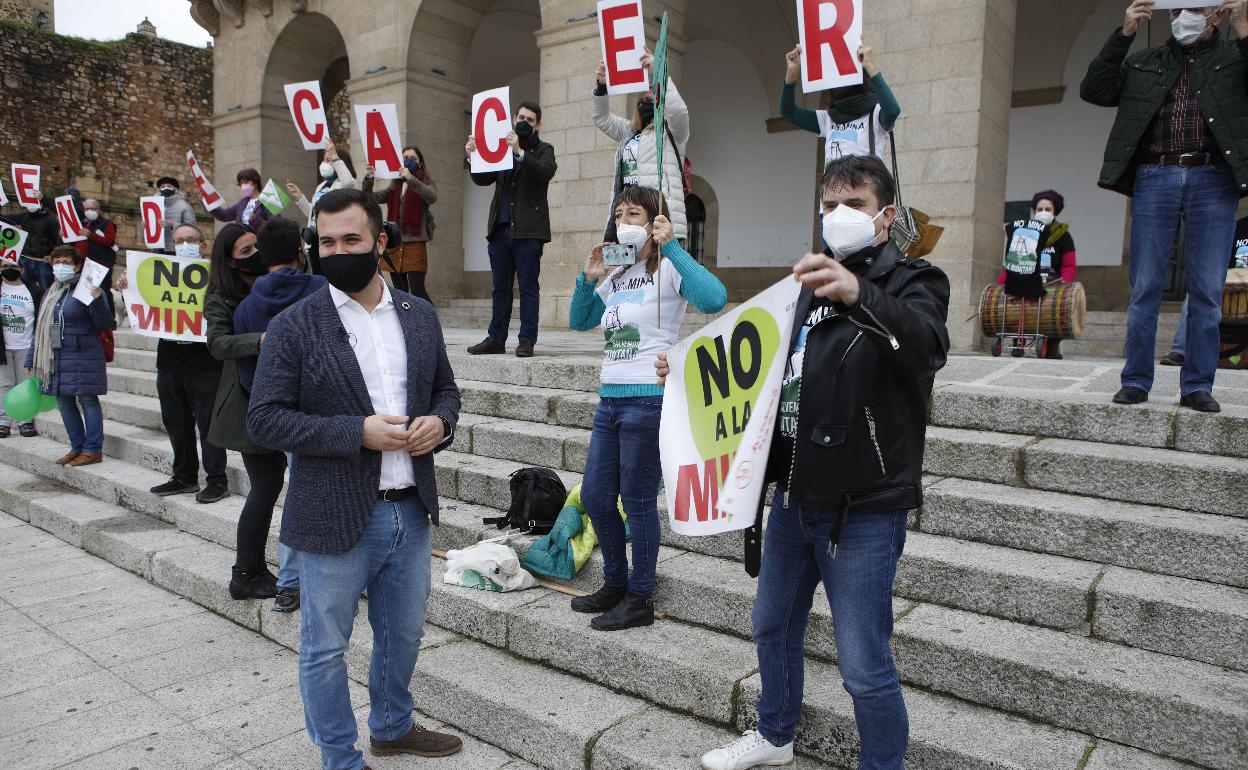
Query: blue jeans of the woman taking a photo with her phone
[[580, 396, 663, 597]]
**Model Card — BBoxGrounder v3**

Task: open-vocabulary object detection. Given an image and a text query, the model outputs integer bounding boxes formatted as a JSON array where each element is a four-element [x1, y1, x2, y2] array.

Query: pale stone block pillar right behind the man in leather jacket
[[864, 0, 1017, 349]]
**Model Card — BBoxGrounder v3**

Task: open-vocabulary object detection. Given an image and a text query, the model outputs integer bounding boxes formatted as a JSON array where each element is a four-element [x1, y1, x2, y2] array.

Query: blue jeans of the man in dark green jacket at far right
[[1122, 160, 1239, 396]]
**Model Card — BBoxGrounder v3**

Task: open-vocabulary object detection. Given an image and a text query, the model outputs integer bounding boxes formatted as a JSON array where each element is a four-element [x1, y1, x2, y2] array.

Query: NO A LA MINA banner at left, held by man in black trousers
[[121, 251, 208, 342]]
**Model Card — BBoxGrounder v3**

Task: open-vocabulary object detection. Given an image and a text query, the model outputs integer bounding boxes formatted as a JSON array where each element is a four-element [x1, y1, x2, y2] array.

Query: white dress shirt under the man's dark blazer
[[329, 277, 416, 489]]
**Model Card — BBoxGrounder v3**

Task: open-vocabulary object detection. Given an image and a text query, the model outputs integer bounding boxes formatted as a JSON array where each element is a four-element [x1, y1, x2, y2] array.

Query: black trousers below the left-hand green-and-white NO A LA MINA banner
[[156, 366, 226, 487]]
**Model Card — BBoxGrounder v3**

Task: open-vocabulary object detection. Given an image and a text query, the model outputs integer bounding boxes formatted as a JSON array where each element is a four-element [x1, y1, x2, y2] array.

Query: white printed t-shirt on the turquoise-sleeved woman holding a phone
[[594, 260, 689, 384]]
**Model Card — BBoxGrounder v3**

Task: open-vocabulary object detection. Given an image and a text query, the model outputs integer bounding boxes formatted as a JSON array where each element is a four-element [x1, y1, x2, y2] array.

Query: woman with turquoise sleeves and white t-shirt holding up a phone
[[568, 186, 728, 631]]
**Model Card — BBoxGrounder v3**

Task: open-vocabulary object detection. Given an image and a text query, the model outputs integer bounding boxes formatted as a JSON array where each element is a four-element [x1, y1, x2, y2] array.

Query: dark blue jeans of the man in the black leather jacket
[[754, 489, 910, 770]]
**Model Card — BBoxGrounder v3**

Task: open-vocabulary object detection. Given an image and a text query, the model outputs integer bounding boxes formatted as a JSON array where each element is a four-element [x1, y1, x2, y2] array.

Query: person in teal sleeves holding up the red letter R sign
[[780, 44, 901, 166]]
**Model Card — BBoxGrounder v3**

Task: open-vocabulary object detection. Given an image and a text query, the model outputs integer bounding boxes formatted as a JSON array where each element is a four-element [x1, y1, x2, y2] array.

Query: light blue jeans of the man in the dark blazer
[[298, 497, 431, 770]]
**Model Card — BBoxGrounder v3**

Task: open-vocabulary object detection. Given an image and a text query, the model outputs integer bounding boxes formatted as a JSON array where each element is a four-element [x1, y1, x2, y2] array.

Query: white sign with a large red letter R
[[797, 0, 862, 94]]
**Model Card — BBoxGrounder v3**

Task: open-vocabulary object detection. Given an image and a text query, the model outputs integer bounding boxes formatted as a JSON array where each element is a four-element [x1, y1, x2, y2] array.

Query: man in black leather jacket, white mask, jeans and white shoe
[[683, 157, 950, 770]]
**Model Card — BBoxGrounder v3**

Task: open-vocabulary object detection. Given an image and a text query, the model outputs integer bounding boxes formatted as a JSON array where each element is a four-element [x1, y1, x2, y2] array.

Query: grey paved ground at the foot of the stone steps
[[0, 513, 530, 770]]
